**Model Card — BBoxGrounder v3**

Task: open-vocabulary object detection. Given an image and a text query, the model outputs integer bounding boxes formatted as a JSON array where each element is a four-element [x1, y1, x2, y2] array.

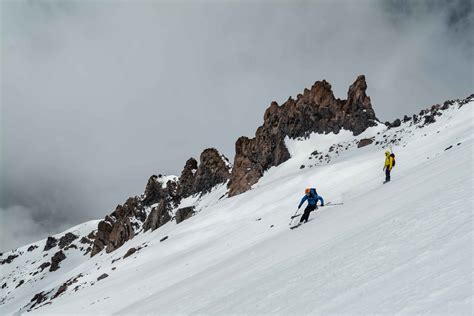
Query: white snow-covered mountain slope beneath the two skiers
[[0, 101, 474, 315]]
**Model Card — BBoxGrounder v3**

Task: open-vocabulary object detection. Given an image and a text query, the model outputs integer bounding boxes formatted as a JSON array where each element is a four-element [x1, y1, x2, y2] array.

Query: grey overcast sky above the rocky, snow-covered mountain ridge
[[0, 0, 474, 251]]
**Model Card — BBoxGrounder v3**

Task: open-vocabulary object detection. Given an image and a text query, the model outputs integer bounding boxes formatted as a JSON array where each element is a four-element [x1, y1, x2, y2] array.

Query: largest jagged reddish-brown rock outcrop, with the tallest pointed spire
[[228, 76, 377, 196]]
